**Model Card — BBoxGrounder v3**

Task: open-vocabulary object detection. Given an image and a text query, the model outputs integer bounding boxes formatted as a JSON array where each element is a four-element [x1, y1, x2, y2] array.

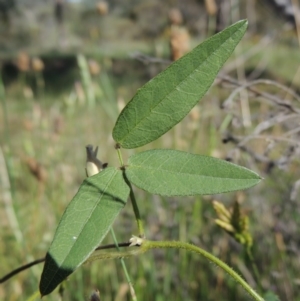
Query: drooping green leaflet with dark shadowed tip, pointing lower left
[[40, 167, 129, 296]]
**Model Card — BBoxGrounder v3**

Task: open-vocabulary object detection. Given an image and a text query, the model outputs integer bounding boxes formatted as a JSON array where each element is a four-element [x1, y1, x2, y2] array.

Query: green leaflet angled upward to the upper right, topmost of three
[[113, 20, 248, 148]]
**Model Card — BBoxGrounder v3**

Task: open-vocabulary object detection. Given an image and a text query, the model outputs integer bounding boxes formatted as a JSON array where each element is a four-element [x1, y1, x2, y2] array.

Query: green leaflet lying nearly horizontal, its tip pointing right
[[125, 149, 261, 196]]
